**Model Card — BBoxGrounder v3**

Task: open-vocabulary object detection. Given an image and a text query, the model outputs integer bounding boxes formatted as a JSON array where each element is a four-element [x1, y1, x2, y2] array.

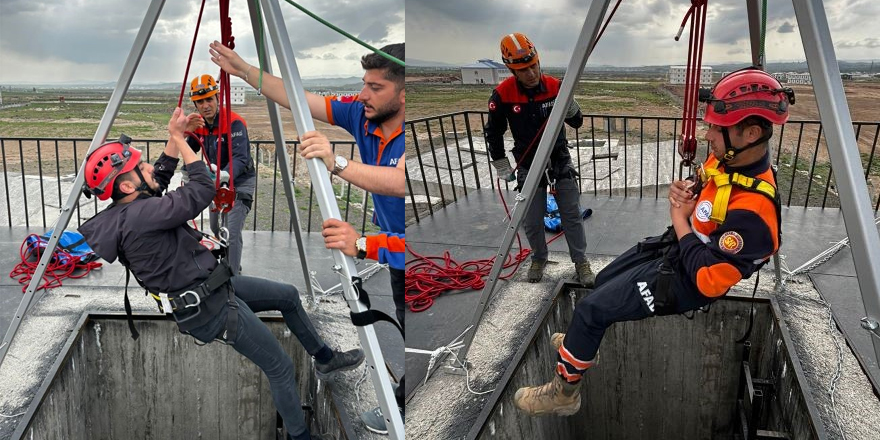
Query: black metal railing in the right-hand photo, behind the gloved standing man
[[405, 111, 880, 223]]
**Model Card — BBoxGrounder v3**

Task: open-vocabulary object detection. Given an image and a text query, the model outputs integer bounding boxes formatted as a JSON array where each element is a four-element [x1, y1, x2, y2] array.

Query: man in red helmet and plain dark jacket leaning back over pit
[[79, 108, 364, 439]]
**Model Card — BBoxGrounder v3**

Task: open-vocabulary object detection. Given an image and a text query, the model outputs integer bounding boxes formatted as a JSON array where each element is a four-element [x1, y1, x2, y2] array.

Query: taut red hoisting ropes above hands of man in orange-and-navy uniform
[[675, 0, 706, 177]]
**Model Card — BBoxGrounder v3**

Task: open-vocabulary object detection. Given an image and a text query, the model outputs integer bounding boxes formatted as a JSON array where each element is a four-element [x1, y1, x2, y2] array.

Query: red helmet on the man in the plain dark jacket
[[85, 135, 141, 200]]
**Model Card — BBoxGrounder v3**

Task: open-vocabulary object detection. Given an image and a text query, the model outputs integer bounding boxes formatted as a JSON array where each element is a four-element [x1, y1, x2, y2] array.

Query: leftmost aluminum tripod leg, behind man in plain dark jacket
[[0, 0, 165, 364]]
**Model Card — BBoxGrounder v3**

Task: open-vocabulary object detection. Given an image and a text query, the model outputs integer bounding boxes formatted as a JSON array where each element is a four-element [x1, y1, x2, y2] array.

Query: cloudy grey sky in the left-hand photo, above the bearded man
[[0, 0, 403, 81]]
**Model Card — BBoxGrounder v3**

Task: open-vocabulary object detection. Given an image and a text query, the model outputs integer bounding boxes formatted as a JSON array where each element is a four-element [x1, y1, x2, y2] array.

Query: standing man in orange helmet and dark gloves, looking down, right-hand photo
[[484, 33, 595, 287]]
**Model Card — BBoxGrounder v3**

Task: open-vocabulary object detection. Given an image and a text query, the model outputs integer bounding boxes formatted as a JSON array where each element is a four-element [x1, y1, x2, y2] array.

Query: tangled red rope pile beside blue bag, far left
[[9, 234, 102, 293]]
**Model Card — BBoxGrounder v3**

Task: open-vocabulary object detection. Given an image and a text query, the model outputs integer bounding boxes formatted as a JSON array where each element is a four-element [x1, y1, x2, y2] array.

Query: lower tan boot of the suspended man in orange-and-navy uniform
[[513, 374, 581, 416]]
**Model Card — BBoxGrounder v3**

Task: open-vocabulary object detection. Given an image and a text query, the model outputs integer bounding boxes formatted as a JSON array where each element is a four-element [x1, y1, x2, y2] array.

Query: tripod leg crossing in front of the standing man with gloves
[[458, 0, 611, 359]]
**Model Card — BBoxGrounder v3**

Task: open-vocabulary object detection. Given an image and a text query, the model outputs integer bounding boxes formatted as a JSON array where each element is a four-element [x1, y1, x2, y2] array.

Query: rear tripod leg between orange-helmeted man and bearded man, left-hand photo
[[248, 1, 315, 305]]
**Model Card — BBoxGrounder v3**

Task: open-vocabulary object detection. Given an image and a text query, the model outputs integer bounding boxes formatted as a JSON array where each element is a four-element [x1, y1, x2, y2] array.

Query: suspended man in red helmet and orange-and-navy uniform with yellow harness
[[514, 68, 794, 415]]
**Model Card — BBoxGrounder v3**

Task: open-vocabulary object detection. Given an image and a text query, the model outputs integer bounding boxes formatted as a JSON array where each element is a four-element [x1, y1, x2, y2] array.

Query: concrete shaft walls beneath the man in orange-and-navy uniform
[[471, 288, 824, 440]]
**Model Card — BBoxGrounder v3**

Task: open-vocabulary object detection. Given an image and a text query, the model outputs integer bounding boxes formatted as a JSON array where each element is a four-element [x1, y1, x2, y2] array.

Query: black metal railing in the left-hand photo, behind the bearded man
[[0, 137, 378, 233]]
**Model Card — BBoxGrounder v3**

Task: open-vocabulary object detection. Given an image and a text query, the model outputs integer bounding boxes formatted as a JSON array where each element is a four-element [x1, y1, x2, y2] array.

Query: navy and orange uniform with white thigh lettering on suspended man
[[556, 151, 779, 382]]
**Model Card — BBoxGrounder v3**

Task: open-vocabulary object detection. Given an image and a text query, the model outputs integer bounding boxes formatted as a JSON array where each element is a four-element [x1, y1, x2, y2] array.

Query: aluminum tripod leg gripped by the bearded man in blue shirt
[[261, 0, 404, 440]]
